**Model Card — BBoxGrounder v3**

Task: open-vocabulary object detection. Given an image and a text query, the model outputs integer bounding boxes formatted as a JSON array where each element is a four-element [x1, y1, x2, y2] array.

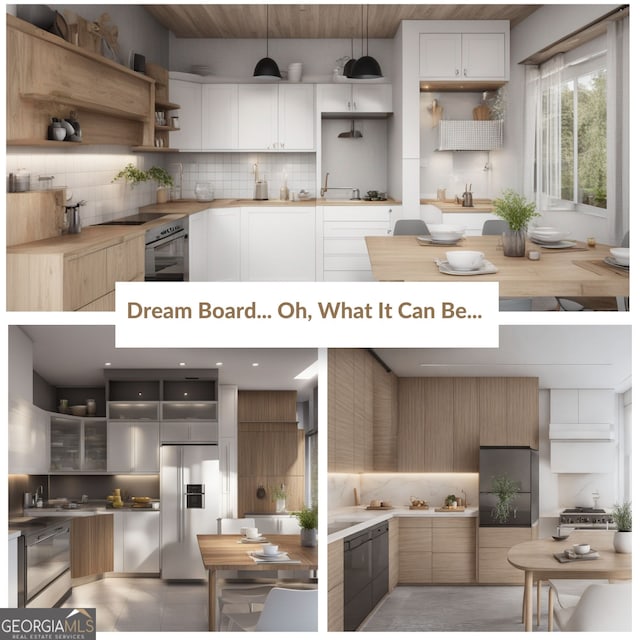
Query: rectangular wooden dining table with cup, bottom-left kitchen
[[198, 534, 318, 631]]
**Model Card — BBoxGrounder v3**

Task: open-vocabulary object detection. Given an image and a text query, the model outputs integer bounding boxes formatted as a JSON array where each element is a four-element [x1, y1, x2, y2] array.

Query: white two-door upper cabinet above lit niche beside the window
[[420, 33, 508, 80]]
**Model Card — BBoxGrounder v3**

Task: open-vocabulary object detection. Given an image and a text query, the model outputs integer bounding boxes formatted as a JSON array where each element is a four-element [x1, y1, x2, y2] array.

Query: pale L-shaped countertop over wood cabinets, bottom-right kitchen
[[327, 506, 479, 544]]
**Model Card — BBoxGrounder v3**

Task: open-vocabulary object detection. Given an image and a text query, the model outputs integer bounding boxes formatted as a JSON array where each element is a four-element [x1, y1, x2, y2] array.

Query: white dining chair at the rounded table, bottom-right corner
[[549, 580, 633, 631]]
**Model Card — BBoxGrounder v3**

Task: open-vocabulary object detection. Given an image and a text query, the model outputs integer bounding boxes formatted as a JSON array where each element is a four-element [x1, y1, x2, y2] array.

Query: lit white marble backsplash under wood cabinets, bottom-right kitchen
[[327, 473, 478, 512]]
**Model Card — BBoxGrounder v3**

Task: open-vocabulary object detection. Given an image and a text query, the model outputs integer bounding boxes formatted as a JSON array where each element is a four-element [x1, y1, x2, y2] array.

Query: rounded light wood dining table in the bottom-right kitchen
[[507, 530, 631, 631]]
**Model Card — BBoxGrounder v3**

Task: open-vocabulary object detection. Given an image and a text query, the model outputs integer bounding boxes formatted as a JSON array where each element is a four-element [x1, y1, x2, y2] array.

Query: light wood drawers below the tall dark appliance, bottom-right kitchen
[[478, 527, 536, 584]]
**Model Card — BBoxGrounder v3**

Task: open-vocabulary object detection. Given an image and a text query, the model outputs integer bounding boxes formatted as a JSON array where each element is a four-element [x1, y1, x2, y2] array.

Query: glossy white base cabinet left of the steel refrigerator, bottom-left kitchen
[[113, 510, 160, 573]]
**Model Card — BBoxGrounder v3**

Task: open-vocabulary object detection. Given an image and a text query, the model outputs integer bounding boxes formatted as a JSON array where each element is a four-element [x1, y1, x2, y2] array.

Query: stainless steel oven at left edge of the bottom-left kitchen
[[17, 518, 71, 607]]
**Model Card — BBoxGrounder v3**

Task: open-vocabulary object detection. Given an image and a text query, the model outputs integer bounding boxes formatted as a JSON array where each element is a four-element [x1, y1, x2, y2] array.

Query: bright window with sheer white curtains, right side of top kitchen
[[524, 19, 629, 236]]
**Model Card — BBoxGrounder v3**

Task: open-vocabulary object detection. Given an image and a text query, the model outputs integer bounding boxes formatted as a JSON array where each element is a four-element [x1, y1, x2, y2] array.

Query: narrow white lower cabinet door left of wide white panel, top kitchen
[[205, 207, 242, 282]]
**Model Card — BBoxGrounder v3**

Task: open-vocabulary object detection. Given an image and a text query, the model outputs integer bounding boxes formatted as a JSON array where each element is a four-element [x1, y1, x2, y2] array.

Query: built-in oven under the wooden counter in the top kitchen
[[144, 217, 189, 282]]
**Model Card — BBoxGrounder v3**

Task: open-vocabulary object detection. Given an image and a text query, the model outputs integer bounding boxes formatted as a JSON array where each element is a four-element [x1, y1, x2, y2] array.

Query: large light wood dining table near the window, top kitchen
[[365, 236, 629, 308]]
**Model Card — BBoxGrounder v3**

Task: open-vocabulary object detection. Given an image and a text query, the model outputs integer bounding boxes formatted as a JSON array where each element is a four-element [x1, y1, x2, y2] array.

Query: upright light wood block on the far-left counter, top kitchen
[[7, 189, 65, 247]]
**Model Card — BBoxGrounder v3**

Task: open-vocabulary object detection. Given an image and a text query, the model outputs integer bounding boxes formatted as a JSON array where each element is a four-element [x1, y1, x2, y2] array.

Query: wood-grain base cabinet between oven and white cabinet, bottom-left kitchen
[[71, 514, 113, 578]]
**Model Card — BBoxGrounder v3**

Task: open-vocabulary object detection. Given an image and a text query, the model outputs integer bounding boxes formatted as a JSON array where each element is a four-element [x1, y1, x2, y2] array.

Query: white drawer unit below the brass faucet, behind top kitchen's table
[[323, 205, 401, 282]]
